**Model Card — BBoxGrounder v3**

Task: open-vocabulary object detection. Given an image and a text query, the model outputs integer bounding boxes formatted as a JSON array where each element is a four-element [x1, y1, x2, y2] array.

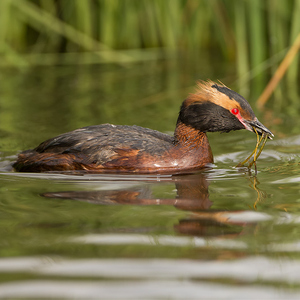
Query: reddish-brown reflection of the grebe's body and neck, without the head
[[42, 173, 212, 211]]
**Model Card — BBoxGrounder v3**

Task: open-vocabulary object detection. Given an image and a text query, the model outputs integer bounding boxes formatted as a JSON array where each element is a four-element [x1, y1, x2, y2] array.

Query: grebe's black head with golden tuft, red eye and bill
[[178, 81, 274, 138]]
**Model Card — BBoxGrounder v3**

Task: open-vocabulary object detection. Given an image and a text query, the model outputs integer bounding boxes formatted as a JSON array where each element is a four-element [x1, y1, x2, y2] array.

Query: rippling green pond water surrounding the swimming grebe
[[0, 62, 300, 299]]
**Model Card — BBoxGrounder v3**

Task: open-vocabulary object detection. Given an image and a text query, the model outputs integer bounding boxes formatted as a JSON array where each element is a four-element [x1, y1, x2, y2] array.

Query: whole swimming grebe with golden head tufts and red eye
[[13, 82, 272, 174]]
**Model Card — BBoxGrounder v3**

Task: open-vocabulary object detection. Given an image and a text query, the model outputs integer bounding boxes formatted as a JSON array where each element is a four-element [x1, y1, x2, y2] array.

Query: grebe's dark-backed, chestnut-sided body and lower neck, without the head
[[15, 124, 213, 173]]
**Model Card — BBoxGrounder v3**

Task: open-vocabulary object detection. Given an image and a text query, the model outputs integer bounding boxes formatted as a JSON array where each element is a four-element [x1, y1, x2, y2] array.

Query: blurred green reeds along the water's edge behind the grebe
[[0, 0, 300, 107]]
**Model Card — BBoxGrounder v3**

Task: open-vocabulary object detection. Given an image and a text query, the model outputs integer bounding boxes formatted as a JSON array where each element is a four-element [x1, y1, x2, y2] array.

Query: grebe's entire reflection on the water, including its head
[[42, 173, 255, 238]]
